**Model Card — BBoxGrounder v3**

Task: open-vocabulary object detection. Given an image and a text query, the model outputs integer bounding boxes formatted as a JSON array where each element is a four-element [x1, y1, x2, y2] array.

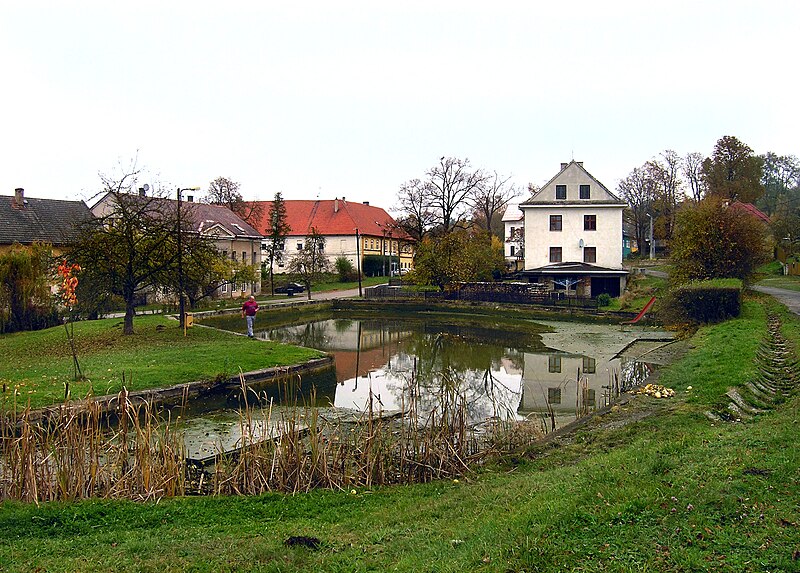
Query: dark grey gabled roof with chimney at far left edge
[[0, 195, 92, 246]]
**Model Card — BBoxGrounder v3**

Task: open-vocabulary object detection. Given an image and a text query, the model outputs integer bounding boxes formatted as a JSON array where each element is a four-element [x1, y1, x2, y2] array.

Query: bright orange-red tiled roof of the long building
[[250, 199, 411, 240]]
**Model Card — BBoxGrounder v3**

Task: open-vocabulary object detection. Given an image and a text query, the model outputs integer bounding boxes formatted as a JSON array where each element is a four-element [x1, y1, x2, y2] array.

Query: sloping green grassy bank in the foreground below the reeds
[[0, 299, 800, 572]]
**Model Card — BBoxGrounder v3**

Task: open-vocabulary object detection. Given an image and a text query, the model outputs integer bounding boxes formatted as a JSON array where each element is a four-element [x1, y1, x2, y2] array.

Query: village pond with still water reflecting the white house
[[192, 313, 668, 442]]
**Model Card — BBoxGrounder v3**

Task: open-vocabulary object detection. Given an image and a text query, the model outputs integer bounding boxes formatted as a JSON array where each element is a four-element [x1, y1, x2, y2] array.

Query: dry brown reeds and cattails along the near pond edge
[[0, 368, 540, 503]]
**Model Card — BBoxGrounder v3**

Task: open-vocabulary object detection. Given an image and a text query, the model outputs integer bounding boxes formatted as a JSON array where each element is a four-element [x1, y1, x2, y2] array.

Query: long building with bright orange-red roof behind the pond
[[248, 198, 414, 275]]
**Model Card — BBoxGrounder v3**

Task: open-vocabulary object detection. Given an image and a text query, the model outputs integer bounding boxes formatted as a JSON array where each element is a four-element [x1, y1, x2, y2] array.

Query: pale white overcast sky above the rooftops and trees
[[0, 0, 800, 209]]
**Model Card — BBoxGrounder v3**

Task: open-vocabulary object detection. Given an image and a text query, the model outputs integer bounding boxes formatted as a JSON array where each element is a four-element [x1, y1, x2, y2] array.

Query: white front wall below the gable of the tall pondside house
[[524, 206, 622, 269]]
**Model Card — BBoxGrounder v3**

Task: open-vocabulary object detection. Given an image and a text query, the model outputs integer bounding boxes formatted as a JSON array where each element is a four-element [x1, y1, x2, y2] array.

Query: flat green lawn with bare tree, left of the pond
[[0, 315, 321, 408]]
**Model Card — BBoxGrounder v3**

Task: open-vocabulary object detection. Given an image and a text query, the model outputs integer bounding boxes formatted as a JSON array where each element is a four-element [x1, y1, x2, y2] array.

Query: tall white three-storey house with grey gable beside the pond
[[519, 160, 627, 297]]
